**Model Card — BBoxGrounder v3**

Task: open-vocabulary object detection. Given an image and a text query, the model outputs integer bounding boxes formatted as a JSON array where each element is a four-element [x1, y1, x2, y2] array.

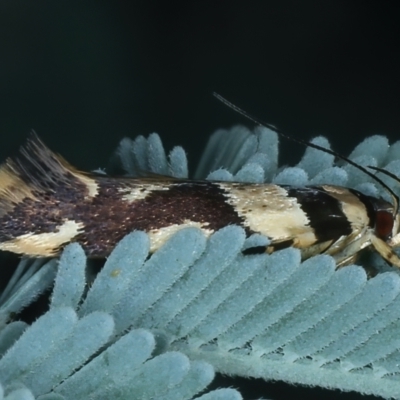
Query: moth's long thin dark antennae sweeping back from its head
[[213, 92, 399, 216]]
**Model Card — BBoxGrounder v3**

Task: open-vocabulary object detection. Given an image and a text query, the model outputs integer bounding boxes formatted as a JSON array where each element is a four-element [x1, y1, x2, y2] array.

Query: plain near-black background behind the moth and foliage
[[0, 0, 400, 399]]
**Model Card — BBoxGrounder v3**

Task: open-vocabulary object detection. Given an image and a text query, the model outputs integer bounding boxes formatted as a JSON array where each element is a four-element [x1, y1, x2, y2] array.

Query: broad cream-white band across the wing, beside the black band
[[218, 183, 316, 248]]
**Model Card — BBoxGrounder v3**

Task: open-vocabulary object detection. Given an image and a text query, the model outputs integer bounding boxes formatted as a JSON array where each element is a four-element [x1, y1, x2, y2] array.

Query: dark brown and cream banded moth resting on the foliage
[[0, 115, 400, 267]]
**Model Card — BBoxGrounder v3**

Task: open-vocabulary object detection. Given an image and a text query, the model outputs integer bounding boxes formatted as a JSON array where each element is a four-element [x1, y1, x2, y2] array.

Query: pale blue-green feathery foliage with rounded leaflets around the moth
[[0, 127, 400, 400]]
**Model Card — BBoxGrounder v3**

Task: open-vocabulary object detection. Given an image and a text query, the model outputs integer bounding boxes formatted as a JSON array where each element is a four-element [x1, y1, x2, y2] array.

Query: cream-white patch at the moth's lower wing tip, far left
[[0, 220, 83, 257]]
